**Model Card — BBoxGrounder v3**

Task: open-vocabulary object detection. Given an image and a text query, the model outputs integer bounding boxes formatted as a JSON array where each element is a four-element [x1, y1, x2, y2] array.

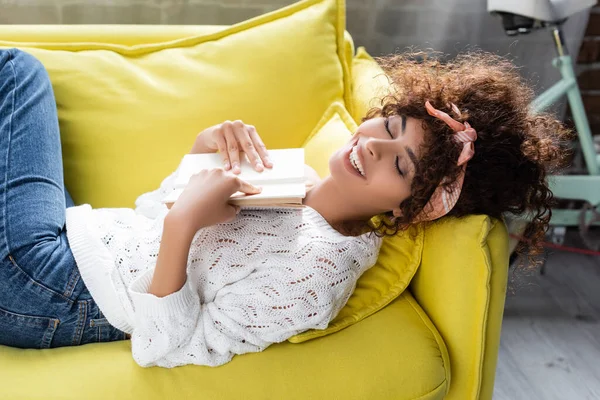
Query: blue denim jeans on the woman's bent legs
[[0, 49, 126, 348]]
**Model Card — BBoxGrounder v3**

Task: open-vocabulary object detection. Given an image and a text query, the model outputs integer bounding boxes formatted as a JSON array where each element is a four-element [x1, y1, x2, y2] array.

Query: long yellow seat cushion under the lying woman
[[0, 291, 449, 400]]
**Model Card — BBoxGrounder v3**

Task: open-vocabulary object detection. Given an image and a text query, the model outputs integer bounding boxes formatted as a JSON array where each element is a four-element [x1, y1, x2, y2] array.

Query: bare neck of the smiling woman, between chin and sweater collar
[[303, 177, 371, 233]]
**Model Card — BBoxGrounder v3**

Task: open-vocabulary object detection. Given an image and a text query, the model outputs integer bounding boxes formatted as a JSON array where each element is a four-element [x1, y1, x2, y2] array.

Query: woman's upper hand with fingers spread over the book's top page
[[190, 120, 273, 174]]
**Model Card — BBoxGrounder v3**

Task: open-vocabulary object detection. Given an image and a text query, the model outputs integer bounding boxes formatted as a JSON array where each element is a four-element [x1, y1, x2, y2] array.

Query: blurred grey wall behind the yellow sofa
[[0, 0, 588, 104]]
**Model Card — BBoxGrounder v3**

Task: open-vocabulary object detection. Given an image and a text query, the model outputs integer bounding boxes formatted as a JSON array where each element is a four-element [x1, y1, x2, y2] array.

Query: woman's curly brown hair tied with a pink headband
[[363, 51, 572, 255]]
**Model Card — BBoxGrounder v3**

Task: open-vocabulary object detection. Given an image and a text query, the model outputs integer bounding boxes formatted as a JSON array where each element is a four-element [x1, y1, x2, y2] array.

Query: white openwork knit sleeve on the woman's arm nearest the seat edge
[[130, 238, 376, 368]]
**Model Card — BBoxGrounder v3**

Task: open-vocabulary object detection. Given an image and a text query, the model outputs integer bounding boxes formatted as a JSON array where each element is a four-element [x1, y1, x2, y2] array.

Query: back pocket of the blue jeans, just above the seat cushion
[[0, 308, 59, 349]]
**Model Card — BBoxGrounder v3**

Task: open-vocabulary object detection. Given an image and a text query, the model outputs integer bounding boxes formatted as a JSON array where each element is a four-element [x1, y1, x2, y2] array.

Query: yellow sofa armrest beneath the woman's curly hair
[[410, 216, 509, 400]]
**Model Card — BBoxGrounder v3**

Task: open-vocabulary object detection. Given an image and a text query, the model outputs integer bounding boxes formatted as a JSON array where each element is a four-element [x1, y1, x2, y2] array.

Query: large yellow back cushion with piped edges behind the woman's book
[[0, 0, 349, 207]]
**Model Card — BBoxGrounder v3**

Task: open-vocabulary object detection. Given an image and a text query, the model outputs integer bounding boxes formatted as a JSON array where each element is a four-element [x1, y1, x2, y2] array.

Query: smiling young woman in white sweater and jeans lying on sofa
[[0, 49, 568, 367]]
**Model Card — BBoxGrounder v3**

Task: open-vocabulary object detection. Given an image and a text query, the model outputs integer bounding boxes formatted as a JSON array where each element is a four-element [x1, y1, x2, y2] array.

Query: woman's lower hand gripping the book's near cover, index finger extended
[[166, 168, 261, 235]]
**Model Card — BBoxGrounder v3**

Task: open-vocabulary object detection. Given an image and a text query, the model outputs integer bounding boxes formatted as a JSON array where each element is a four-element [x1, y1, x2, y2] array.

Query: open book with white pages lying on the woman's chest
[[162, 149, 306, 207]]
